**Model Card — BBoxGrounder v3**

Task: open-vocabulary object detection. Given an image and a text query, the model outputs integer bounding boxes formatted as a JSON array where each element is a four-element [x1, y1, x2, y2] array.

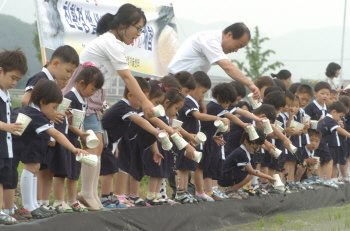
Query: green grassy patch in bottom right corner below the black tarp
[[216, 204, 350, 231]]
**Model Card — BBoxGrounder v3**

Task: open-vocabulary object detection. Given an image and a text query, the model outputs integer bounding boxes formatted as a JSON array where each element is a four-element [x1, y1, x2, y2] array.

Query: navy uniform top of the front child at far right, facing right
[[317, 114, 341, 147]]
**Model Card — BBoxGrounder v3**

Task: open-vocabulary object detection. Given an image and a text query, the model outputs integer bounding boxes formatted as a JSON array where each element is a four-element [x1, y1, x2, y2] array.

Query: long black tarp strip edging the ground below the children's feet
[[0, 184, 350, 231]]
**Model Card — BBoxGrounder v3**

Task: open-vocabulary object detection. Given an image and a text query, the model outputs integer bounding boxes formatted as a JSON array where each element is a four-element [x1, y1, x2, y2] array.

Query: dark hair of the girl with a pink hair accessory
[[75, 66, 105, 89]]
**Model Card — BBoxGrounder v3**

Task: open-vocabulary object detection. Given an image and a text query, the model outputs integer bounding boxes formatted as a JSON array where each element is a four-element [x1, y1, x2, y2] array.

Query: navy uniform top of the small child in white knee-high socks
[[13, 103, 54, 159]]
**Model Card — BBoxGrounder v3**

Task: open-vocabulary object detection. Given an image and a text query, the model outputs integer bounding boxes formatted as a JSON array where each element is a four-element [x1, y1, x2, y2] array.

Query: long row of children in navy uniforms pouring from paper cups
[[0, 46, 350, 224]]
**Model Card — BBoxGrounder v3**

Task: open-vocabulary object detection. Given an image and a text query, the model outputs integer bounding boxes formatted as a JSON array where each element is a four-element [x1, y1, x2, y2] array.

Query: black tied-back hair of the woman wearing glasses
[[96, 3, 147, 35]]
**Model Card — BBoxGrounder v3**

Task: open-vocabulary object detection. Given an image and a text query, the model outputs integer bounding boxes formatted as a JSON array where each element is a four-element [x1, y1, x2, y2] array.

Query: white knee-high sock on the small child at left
[[21, 169, 37, 211]]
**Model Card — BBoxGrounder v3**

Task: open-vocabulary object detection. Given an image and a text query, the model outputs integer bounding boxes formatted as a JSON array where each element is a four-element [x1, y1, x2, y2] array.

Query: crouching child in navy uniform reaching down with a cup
[[219, 128, 274, 199]]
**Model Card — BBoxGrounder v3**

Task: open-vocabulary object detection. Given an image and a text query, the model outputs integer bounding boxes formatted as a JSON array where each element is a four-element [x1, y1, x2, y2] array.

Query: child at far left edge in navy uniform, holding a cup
[[0, 50, 28, 225]]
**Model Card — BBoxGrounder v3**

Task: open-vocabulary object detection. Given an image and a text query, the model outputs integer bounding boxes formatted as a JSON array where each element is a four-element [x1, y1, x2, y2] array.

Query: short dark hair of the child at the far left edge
[[0, 49, 28, 75]]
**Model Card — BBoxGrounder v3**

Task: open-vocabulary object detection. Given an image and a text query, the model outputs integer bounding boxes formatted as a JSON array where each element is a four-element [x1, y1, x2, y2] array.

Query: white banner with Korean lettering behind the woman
[[36, 0, 178, 76]]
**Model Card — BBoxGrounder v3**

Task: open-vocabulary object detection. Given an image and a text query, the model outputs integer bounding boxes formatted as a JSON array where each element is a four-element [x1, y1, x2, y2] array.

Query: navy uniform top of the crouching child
[[223, 144, 251, 176]]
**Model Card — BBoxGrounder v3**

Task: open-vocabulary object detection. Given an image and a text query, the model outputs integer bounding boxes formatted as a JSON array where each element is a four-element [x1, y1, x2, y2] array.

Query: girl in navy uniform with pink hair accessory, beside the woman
[[51, 63, 104, 212]]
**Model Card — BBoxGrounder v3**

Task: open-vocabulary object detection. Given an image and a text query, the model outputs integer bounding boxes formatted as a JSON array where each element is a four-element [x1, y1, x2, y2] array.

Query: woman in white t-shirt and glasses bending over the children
[[65, 4, 153, 210]]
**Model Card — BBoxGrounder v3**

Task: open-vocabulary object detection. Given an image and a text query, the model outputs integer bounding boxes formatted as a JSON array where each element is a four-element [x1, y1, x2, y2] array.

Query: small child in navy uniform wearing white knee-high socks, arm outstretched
[[14, 80, 87, 218]]
